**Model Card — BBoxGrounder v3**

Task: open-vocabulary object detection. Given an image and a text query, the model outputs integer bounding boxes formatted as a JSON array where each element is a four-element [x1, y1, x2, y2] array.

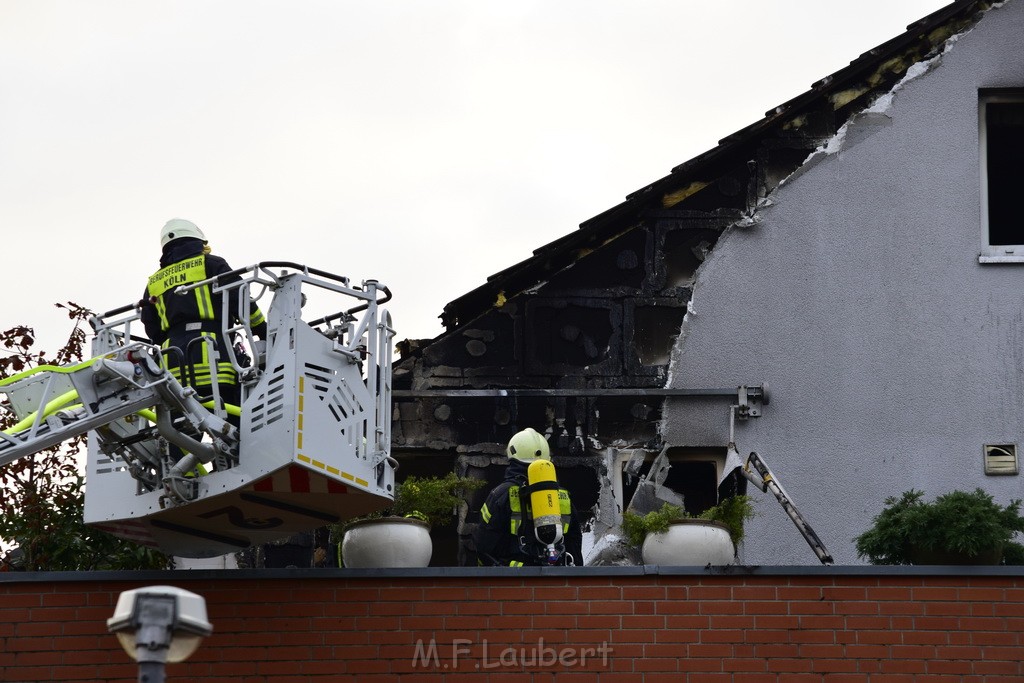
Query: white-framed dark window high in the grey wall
[[979, 90, 1024, 263]]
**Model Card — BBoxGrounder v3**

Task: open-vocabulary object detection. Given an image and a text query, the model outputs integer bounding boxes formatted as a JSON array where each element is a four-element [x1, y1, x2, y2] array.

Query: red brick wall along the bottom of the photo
[[0, 567, 1024, 683]]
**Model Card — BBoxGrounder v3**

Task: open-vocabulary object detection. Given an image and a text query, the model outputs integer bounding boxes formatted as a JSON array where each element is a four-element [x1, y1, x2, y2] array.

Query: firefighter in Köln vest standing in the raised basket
[[139, 218, 266, 436]]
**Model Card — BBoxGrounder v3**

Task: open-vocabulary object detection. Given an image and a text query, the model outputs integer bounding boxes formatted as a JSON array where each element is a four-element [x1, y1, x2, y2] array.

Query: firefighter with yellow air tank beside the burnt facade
[[475, 428, 583, 566]]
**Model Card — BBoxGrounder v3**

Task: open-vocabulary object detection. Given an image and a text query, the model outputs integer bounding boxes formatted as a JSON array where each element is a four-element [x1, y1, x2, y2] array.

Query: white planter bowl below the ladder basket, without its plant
[[341, 517, 433, 568]]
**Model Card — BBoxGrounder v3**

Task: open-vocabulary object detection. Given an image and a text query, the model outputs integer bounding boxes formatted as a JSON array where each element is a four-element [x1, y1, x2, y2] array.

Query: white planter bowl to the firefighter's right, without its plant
[[640, 519, 736, 566]]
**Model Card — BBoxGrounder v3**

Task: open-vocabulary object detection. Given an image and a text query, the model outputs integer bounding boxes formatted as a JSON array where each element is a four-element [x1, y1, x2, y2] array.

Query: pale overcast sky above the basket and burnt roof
[[0, 0, 947, 349]]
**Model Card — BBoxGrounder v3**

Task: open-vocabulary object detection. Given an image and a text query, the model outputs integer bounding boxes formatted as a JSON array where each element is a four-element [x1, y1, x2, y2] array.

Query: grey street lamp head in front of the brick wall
[[106, 586, 213, 683]]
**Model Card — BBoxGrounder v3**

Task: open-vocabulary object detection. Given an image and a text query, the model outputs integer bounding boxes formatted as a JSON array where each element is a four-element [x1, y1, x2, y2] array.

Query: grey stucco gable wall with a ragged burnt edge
[[663, 0, 1024, 564]]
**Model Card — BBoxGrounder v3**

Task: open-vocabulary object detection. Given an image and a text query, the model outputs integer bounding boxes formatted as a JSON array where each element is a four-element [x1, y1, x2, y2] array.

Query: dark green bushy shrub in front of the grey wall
[[854, 488, 1024, 564]]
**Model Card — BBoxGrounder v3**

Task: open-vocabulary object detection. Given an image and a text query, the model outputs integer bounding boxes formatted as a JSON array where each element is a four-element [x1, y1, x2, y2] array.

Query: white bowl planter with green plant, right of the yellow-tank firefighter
[[623, 496, 754, 566]]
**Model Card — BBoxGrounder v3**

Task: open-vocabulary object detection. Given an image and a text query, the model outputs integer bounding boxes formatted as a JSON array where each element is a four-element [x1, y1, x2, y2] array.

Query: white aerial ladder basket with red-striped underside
[[0, 262, 395, 557]]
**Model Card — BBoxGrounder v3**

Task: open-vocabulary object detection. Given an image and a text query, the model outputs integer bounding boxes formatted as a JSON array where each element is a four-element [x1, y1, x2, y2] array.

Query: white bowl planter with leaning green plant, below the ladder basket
[[332, 472, 484, 567]]
